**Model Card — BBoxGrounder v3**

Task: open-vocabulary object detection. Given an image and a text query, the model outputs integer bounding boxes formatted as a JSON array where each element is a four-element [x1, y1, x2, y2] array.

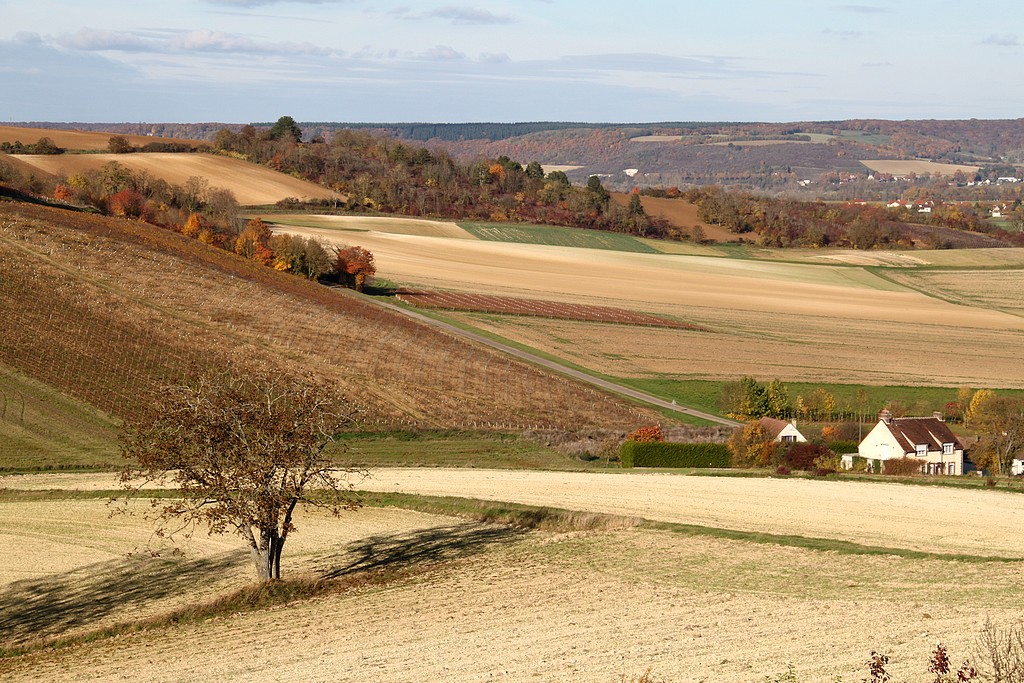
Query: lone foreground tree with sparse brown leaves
[[121, 371, 358, 581]]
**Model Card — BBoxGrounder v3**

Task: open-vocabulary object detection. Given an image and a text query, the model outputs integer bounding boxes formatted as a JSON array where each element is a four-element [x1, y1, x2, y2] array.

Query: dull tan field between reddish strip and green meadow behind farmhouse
[[450, 308, 1024, 388]]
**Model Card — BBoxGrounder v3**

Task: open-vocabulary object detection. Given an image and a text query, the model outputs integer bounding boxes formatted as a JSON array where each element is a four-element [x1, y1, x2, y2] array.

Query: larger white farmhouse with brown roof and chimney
[[857, 410, 964, 474]]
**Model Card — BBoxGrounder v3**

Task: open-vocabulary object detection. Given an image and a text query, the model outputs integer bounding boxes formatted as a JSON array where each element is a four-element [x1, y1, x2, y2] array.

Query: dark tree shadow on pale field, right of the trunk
[[321, 522, 526, 579]]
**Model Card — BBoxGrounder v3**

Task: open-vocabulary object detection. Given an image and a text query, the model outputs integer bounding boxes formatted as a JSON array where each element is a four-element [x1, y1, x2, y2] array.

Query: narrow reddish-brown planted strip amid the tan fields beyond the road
[[396, 290, 701, 331]]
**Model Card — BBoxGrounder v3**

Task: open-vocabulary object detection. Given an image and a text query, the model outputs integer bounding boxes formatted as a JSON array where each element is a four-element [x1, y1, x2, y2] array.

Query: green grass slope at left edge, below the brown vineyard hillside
[[0, 366, 122, 470]]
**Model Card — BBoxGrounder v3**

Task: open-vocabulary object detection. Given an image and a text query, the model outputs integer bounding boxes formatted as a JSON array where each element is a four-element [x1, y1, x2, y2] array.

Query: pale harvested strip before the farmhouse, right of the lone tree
[[359, 468, 1024, 559]]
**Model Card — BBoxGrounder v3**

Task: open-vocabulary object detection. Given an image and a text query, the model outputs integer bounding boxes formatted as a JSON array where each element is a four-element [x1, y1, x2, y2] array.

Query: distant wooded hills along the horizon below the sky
[[14, 119, 1024, 194]]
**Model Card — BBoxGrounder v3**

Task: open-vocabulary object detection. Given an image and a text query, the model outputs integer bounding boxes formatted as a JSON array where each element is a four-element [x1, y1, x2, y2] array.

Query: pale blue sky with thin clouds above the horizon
[[0, 0, 1024, 123]]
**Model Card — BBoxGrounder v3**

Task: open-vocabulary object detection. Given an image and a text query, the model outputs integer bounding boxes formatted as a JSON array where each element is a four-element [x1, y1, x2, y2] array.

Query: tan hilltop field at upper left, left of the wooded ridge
[[15, 153, 337, 205]]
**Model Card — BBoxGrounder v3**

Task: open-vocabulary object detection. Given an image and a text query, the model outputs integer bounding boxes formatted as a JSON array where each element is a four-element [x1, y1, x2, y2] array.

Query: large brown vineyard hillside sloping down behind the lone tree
[[0, 202, 653, 428]]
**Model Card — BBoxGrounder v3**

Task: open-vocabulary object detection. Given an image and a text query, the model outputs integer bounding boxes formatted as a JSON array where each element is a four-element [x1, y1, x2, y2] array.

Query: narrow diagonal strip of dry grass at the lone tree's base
[[0, 565, 428, 659]]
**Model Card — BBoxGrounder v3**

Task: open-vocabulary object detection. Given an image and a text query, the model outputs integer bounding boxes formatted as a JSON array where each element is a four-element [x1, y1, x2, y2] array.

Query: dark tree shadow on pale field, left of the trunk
[[0, 551, 249, 646]]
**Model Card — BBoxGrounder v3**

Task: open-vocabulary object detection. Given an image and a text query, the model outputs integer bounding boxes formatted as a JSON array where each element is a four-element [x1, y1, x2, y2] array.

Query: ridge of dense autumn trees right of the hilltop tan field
[[214, 126, 678, 238]]
